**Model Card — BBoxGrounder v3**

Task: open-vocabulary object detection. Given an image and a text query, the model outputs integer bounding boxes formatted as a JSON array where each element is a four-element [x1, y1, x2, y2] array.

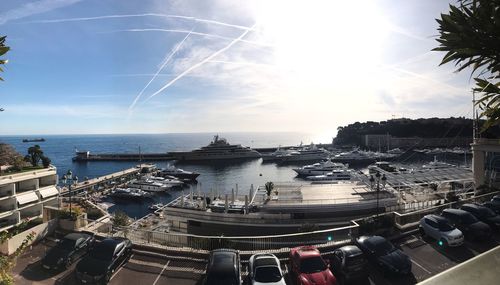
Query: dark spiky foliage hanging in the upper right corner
[[433, 0, 500, 131]]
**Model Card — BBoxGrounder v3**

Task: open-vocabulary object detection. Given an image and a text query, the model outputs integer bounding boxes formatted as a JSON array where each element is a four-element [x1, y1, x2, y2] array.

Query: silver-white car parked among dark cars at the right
[[419, 215, 464, 246]]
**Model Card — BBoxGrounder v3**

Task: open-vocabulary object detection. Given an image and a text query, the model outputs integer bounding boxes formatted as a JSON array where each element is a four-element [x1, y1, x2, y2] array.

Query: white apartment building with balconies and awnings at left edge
[[0, 166, 59, 231]]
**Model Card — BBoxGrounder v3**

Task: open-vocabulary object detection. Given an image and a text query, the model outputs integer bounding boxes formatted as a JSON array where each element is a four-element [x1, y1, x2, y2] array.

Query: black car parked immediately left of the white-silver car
[[204, 249, 242, 285]]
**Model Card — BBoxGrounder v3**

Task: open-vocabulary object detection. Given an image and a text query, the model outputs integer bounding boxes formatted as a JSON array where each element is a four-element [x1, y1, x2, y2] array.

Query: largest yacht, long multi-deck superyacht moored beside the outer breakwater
[[170, 135, 261, 161]]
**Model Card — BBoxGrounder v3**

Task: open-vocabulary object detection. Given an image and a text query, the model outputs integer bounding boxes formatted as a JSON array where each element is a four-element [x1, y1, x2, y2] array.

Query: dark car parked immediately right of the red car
[[330, 245, 368, 282]]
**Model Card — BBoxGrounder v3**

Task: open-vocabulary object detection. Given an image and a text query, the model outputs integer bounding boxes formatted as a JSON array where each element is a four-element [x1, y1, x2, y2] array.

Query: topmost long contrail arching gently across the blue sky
[[26, 13, 250, 30]]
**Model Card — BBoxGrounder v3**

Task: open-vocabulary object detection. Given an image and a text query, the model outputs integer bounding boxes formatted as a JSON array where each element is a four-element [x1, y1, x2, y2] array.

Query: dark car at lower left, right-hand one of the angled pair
[[76, 237, 132, 284]]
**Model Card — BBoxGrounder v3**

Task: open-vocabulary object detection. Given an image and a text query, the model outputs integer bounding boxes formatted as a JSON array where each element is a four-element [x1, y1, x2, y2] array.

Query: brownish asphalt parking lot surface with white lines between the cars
[[14, 233, 500, 285]]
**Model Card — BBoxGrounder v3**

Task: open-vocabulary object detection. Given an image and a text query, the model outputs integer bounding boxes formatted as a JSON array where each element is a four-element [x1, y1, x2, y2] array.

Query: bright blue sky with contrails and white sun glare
[[0, 0, 472, 140]]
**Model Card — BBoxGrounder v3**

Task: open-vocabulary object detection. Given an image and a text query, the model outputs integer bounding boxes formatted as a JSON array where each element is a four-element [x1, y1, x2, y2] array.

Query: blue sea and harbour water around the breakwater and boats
[[0, 132, 331, 218]]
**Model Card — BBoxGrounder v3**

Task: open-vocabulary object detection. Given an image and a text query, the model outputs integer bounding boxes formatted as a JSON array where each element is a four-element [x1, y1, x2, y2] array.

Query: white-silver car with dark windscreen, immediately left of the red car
[[248, 253, 286, 285]]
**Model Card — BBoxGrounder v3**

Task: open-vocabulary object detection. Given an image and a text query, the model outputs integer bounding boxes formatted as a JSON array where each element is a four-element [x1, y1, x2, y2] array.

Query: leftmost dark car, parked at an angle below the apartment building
[[41, 233, 94, 270]]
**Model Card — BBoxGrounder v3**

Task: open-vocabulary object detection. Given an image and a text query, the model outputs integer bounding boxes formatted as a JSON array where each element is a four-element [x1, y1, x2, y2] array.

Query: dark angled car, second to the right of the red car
[[356, 236, 411, 275]]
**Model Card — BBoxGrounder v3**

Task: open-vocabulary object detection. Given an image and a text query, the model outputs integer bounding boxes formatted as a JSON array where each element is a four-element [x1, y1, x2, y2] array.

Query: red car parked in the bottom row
[[290, 246, 337, 285]]
